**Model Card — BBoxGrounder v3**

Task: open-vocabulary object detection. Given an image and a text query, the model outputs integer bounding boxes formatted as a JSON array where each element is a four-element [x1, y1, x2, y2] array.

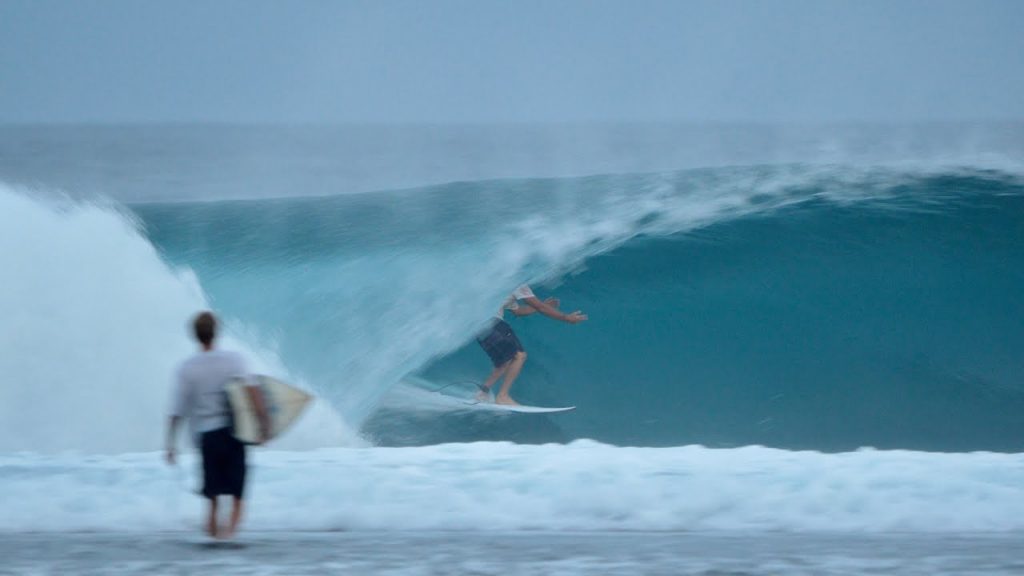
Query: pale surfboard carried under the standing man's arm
[[227, 374, 313, 444]]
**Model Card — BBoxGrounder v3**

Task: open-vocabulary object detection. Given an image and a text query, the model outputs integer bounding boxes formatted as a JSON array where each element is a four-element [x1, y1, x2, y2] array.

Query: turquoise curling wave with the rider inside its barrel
[[125, 165, 1024, 451]]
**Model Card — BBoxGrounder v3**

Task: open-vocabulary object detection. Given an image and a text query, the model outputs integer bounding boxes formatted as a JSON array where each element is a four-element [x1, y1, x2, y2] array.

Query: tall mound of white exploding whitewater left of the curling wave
[[0, 184, 353, 452]]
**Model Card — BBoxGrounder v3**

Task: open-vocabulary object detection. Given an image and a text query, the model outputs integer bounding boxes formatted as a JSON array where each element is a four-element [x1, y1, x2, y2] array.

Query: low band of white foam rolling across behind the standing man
[[0, 441, 1024, 533]]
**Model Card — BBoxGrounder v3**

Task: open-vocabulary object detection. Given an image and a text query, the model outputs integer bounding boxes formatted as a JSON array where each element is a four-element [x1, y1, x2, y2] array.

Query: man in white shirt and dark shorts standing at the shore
[[167, 312, 270, 538]]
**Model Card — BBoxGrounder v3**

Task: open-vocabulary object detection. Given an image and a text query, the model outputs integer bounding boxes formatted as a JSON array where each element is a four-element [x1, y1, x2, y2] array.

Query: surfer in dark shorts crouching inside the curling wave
[[476, 284, 587, 405]]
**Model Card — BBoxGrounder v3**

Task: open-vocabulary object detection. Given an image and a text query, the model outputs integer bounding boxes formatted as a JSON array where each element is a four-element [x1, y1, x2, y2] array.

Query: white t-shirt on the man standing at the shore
[[171, 349, 249, 436]]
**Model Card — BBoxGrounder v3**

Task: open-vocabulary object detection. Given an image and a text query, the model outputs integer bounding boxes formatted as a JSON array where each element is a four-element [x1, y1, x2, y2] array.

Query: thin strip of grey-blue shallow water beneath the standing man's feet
[[0, 532, 1024, 576]]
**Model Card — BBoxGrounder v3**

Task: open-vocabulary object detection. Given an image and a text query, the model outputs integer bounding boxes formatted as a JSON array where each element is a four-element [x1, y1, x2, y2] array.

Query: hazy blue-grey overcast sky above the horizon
[[0, 0, 1024, 123]]
